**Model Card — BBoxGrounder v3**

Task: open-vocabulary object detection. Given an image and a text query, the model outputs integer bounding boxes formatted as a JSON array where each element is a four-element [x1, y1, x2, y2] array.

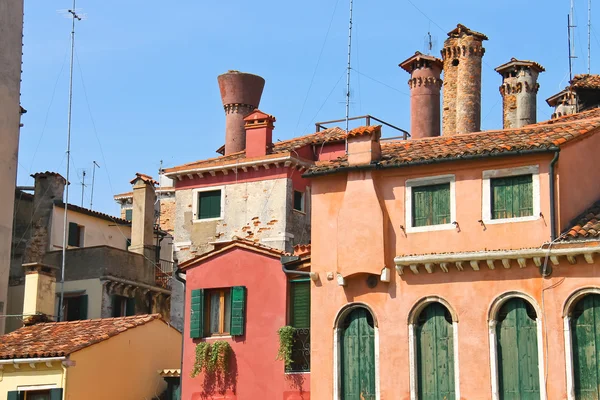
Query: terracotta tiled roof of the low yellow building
[[0, 314, 160, 359]]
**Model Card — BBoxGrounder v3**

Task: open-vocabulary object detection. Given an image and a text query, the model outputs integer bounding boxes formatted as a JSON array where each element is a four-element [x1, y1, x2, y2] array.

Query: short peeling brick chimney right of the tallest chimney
[[496, 58, 545, 129]]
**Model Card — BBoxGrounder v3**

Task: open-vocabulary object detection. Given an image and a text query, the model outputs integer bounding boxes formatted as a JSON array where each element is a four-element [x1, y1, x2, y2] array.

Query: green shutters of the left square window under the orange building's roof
[[412, 183, 451, 227]]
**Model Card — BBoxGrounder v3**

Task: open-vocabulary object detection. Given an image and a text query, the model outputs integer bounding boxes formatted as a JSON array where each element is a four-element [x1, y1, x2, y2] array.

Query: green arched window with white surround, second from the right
[[490, 294, 545, 400]]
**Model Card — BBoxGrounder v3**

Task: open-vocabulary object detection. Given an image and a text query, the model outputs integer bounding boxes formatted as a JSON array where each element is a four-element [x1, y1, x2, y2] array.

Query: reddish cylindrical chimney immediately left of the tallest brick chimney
[[399, 51, 443, 139]]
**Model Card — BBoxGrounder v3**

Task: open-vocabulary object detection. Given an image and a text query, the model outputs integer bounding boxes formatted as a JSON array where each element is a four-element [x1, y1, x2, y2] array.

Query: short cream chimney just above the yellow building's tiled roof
[[23, 263, 58, 325]]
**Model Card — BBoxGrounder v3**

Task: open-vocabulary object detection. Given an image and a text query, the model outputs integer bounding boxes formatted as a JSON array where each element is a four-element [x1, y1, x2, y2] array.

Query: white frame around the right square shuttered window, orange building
[[481, 165, 541, 225]]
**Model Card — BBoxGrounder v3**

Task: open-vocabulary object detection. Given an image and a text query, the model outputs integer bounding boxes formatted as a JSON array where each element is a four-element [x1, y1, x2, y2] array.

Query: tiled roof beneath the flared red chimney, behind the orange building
[[164, 127, 346, 174]]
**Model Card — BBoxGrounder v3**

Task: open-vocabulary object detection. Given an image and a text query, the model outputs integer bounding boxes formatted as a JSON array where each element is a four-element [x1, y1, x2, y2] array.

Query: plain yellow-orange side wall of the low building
[[66, 320, 182, 400]]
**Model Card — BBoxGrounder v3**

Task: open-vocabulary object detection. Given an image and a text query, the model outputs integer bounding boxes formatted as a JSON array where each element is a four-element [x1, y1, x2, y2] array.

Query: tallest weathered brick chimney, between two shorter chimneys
[[442, 24, 487, 135]]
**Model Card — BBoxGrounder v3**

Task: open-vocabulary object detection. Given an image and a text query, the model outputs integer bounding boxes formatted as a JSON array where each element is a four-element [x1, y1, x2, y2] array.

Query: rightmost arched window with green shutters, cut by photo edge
[[565, 288, 600, 399]]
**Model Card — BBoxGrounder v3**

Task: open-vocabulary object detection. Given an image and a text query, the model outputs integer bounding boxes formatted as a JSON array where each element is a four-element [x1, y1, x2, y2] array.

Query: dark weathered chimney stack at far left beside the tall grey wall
[[23, 171, 67, 264]]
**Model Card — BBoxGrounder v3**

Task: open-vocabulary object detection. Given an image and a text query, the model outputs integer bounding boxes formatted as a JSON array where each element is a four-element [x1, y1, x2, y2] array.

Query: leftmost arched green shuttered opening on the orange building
[[340, 307, 375, 400]]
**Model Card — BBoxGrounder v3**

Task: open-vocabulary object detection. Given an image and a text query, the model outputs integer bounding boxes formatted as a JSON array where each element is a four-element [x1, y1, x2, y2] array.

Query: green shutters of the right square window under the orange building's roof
[[490, 174, 533, 219]]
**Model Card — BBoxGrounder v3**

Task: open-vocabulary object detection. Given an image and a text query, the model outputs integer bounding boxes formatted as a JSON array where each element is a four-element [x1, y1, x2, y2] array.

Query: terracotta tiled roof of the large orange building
[[306, 109, 600, 175]]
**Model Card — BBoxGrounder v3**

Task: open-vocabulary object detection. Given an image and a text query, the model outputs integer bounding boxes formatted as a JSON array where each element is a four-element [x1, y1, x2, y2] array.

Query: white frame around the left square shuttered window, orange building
[[404, 174, 456, 233]]
